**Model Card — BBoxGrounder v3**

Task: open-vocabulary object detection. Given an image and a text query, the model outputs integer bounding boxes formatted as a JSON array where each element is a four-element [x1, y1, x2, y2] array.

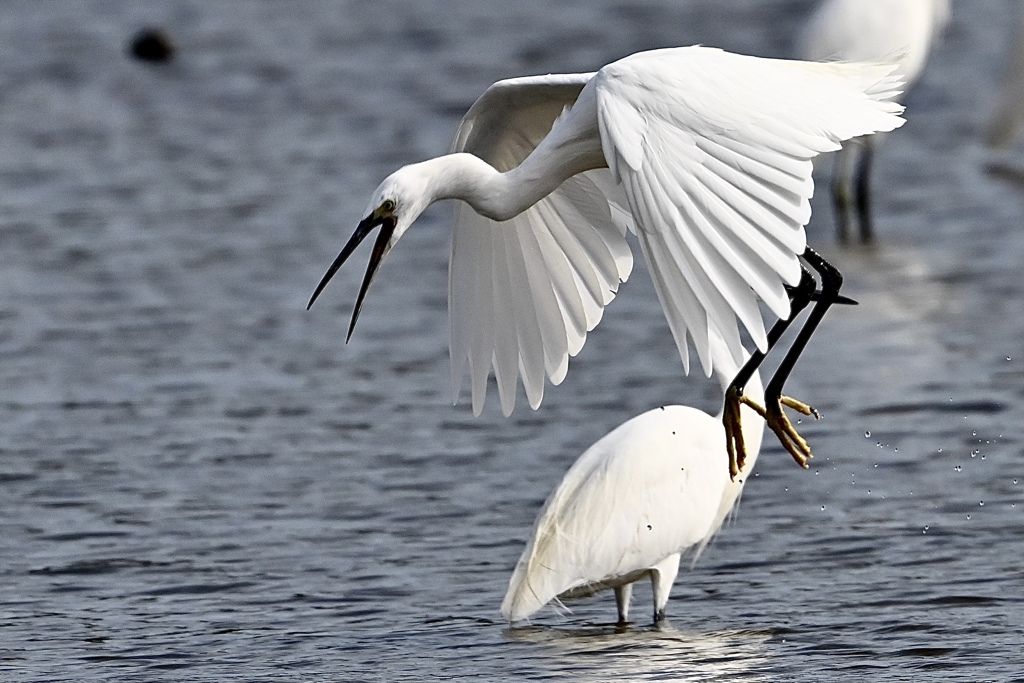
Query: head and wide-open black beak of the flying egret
[[306, 164, 434, 341]]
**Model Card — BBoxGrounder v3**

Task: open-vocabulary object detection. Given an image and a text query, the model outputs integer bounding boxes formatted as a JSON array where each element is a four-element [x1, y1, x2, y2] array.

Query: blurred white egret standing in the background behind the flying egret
[[797, 0, 949, 243]]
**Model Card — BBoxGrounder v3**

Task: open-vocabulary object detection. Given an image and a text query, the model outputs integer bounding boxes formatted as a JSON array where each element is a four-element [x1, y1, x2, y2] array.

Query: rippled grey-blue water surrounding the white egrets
[[0, 0, 1024, 681]]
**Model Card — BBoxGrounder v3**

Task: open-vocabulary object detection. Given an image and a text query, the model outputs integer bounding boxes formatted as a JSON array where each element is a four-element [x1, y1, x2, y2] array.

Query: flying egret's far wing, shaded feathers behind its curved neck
[[449, 74, 633, 415]]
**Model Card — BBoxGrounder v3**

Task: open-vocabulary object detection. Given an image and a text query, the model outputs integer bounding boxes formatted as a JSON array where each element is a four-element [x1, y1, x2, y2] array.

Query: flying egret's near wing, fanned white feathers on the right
[[595, 47, 903, 376]]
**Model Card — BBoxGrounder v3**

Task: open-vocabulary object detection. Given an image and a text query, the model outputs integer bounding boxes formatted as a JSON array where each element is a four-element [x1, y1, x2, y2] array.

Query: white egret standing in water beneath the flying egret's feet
[[502, 271, 840, 624]]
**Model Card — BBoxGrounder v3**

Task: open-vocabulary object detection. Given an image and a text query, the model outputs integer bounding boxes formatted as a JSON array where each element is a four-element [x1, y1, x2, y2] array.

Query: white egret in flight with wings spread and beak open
[[309, 47, 903, 479]]
